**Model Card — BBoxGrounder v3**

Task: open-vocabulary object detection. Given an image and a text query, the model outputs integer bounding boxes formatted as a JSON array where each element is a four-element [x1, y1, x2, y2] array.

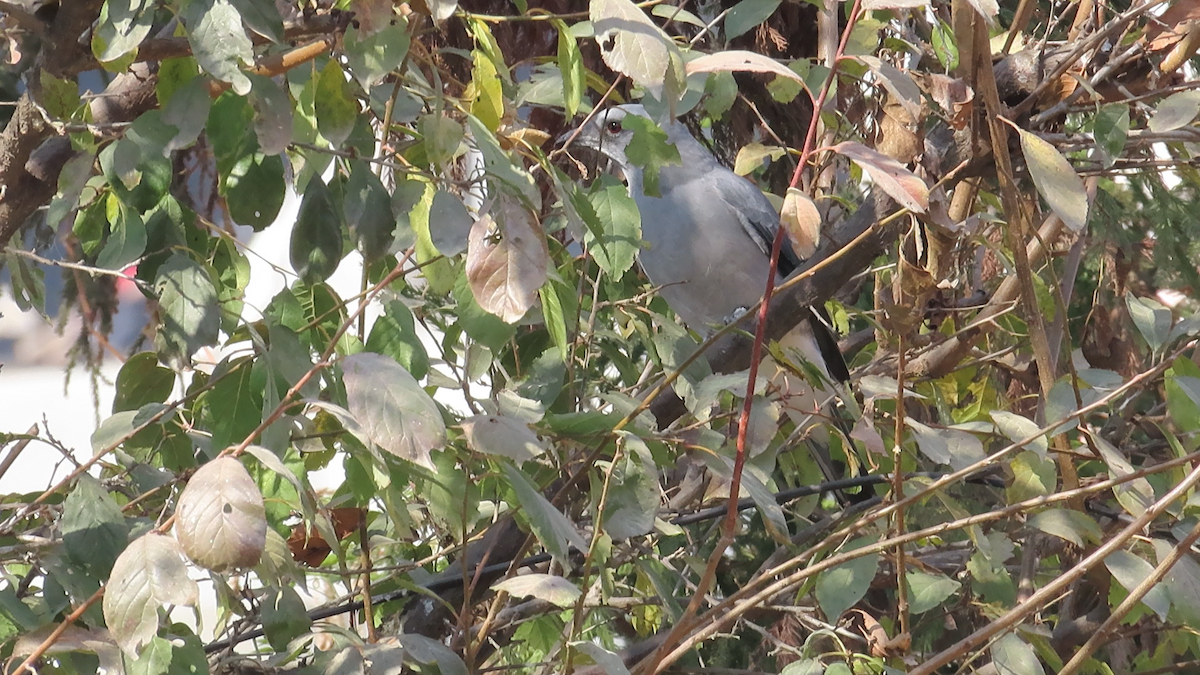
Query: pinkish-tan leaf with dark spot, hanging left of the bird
[[467, 193, 550, 323]]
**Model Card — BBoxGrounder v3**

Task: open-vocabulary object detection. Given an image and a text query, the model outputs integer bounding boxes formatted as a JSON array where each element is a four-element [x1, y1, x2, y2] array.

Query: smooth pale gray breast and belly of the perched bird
[[634, 166, 769, 333]]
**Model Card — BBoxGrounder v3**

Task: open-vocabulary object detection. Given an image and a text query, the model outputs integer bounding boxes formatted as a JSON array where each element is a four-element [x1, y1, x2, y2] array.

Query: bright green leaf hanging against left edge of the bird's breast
[[572, 177, 642, 279]]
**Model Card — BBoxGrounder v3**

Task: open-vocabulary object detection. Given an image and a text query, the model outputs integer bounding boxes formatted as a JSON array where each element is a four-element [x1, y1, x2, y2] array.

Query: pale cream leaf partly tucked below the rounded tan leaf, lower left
[[103, 528, 203, 658]]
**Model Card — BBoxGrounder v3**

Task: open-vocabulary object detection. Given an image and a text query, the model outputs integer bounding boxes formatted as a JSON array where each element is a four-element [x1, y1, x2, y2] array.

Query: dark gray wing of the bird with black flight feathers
[[712, 172, 850, 382]]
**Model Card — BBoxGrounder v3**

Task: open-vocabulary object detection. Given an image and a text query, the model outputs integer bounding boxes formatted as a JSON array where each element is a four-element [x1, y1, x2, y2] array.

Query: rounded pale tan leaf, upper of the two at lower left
[[175, 456, 266, 572]]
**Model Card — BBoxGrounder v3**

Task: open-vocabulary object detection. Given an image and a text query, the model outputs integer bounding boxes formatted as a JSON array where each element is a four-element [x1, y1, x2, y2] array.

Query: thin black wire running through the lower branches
[[204, 471, 1004, 653]]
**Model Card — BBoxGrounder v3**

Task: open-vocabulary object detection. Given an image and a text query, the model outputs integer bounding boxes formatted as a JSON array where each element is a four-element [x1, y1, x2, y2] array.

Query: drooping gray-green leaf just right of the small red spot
[[155, 253, 221, 364]]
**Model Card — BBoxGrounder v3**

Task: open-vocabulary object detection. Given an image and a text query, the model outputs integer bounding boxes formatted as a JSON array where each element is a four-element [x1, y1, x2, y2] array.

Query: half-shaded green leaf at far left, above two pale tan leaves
[[60, 473, 130, 579]]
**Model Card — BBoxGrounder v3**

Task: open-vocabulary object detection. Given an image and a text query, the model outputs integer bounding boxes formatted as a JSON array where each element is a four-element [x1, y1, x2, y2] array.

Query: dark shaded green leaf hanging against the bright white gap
[[289, 177, 342, 283]]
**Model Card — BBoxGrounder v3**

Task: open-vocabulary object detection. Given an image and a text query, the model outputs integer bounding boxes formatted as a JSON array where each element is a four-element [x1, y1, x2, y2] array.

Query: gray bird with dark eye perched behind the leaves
[[561, 104, 850, 479]]
